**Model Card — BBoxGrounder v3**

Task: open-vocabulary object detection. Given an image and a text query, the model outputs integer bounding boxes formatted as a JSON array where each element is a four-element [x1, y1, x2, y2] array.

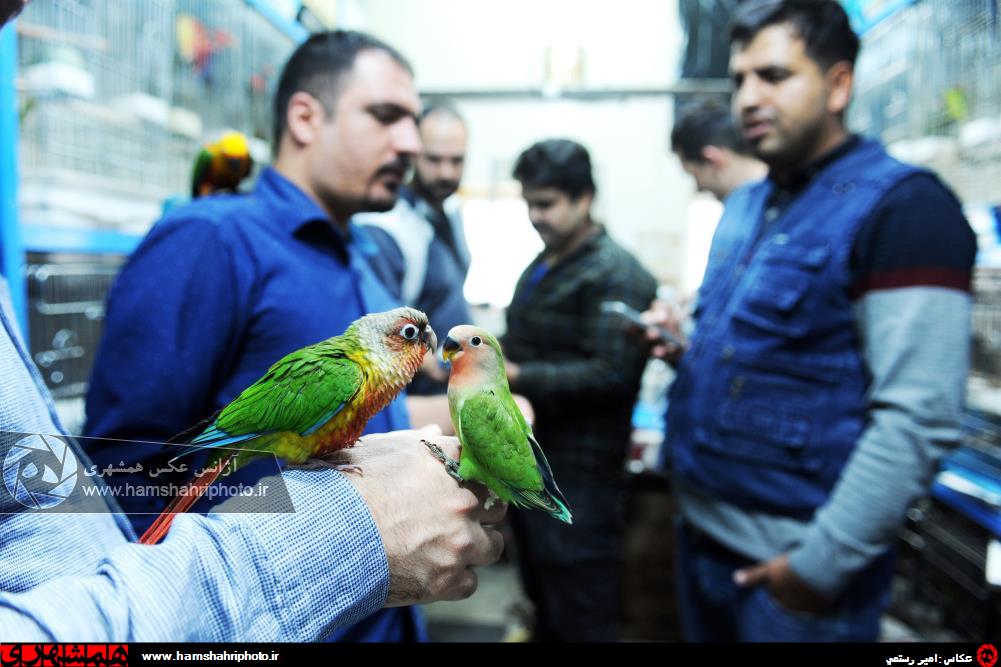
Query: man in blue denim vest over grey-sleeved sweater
[[668, 0, 976, 641]]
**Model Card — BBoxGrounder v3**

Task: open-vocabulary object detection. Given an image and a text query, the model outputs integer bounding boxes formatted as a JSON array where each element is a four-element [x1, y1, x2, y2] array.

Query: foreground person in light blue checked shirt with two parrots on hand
[[0, 2, 504, 642]]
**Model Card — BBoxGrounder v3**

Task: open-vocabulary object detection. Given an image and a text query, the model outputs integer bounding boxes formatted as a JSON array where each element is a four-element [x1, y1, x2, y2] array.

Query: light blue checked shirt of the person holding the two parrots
[[0, 279, 389, 642]]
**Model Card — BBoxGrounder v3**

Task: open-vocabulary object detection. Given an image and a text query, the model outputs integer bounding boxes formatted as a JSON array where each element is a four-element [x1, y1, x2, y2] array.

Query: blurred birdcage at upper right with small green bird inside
[[849, 0, 1001, 202]]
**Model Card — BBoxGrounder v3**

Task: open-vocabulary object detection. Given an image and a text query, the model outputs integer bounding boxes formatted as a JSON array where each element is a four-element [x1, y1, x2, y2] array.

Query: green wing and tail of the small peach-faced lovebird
[[455, 389, 571, 523]]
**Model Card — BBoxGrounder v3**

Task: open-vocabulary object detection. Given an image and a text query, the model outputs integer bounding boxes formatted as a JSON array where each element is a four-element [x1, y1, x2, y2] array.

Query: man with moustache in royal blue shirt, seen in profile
[[78, 32, 480, 640]]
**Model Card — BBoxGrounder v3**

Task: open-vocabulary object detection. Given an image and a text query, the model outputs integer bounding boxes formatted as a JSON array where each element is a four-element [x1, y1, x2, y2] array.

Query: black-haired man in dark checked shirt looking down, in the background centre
[[502, 139, 657, 641]]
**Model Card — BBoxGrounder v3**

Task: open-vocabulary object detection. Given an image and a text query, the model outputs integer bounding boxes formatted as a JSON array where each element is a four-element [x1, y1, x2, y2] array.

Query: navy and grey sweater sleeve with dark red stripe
[[790, 174, 976, 596]]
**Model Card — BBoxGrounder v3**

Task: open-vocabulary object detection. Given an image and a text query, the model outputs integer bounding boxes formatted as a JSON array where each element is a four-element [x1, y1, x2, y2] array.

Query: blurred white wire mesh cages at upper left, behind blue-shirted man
[[18, 0, 294, 200]]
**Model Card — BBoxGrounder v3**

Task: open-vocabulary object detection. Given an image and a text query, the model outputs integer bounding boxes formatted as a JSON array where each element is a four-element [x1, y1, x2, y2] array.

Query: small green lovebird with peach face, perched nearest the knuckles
[[424, 324, 573, 524]]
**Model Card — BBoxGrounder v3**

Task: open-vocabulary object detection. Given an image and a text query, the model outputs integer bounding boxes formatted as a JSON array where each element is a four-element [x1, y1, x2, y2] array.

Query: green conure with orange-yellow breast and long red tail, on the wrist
[[139, 307, 436, 544]]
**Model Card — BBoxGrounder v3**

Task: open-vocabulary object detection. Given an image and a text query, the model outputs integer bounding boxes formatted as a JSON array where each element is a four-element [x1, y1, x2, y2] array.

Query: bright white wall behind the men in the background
[[352, 0, 693, 300]]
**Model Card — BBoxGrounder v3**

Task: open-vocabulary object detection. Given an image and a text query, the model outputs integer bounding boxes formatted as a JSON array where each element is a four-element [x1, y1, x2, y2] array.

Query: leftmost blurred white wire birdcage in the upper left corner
[[18, 0, 174, 197]]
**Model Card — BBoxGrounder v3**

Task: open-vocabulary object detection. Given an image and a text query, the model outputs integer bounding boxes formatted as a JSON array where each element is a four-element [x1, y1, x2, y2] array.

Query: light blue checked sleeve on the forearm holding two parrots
[[0, 470, 389, 642]]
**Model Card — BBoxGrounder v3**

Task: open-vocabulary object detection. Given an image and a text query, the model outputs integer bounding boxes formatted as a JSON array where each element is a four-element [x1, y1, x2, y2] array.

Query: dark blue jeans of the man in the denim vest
[[677, 521, 896, 642]]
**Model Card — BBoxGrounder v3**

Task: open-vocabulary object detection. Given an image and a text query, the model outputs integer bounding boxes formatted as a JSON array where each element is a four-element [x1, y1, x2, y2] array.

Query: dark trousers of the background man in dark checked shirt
[[509, 478, 626, 642]]
